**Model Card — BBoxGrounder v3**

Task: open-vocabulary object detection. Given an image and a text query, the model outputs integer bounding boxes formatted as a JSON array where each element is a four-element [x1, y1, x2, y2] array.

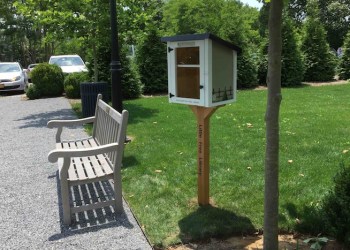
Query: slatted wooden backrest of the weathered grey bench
[[92, 94, 129, 167]]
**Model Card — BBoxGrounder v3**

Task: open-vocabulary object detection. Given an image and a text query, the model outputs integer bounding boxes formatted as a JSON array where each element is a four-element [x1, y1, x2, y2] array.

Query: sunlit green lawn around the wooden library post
[[75, 84, 350, 246]]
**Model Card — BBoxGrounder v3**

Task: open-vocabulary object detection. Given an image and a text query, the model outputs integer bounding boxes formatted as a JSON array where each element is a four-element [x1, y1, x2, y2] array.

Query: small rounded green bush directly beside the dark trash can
[[64, 72, 89, 98]]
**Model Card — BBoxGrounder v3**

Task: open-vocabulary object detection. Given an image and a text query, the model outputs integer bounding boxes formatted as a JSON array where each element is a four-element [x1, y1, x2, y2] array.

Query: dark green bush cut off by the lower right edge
[[323, 164, 350, 247]]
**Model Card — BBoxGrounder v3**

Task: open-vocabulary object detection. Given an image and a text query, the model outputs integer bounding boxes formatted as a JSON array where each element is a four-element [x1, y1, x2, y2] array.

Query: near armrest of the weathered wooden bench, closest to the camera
[[48, 143, 119, 163]]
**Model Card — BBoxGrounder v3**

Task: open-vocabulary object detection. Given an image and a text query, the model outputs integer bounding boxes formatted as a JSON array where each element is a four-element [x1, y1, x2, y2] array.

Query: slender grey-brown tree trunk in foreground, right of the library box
[[264, 0, 283, 250]]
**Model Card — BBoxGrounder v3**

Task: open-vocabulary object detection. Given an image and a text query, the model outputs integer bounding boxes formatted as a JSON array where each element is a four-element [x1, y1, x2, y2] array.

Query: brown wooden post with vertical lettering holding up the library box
[[190, 106, 218, 206]]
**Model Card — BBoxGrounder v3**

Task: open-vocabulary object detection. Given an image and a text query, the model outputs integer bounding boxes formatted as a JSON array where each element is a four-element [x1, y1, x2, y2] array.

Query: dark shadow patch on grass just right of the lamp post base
[[124, 102, 159, 124]]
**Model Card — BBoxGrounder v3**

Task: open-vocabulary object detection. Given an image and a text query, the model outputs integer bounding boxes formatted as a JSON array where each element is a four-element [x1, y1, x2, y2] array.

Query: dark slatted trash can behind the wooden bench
[[80, 82, 108, 118]]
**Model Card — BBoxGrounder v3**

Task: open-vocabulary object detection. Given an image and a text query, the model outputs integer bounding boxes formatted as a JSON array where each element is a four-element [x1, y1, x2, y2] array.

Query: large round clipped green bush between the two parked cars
[[31, 63, 64, 96]]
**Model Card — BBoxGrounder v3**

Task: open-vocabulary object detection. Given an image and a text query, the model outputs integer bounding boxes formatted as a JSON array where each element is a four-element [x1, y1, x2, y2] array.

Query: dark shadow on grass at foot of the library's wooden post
[[179, 205, 256, 243]]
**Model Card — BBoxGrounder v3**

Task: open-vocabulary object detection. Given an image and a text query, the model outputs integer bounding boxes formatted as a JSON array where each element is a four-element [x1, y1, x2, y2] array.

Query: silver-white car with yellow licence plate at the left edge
[[0, 62, 28, 92]]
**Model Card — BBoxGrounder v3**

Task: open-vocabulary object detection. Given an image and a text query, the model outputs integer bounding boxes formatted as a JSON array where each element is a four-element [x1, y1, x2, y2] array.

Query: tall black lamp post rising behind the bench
[[109, 0, 123, 113]]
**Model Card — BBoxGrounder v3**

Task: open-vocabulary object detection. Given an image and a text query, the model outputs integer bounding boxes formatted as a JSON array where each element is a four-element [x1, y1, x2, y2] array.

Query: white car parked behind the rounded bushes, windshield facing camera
[[49, 55, 88, 74]]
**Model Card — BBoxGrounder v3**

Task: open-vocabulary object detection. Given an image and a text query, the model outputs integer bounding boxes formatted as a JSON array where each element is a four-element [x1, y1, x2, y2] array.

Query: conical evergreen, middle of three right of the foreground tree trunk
[[302, 1, 336, 81]]
